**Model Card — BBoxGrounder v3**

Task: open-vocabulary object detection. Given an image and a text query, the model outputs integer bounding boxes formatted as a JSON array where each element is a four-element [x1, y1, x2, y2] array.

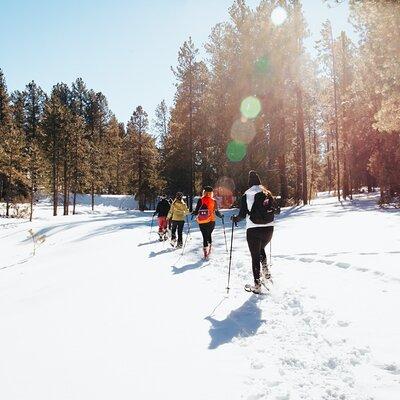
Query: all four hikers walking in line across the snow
[[153, 171, 279, 293]]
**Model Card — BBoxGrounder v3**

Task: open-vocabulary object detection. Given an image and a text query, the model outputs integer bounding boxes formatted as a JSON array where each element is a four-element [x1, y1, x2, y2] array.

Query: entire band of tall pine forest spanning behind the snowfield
[[0, 0, 400, 218]]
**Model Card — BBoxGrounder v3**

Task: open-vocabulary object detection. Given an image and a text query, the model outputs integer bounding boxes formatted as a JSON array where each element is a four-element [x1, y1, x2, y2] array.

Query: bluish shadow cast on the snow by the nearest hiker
[[205, 295, 265, 350]]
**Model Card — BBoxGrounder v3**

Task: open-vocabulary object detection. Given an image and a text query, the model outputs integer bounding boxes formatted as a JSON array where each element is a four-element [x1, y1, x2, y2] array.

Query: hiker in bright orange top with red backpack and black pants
[[192, 186, 224, 259]]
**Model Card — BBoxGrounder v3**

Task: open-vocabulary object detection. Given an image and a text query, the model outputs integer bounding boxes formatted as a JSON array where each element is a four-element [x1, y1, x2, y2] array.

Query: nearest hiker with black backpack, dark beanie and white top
[[231, 171, 278, 294]]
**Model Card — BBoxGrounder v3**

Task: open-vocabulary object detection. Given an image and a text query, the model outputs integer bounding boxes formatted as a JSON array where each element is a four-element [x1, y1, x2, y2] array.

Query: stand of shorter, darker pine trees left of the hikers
[[0, 75, 162, 218]]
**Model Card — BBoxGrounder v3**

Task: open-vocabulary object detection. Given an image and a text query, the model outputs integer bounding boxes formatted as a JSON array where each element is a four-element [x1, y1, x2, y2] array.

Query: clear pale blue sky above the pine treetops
[[0, 0, 352, 128]]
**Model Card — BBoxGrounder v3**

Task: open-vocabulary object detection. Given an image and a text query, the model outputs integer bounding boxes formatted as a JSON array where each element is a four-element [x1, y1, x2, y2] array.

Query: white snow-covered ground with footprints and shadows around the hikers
[[0, 195, 400, 400]]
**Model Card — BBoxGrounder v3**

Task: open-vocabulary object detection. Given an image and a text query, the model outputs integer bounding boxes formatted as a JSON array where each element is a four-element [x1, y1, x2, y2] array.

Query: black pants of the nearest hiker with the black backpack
[[247, 226, 274, 282]]
